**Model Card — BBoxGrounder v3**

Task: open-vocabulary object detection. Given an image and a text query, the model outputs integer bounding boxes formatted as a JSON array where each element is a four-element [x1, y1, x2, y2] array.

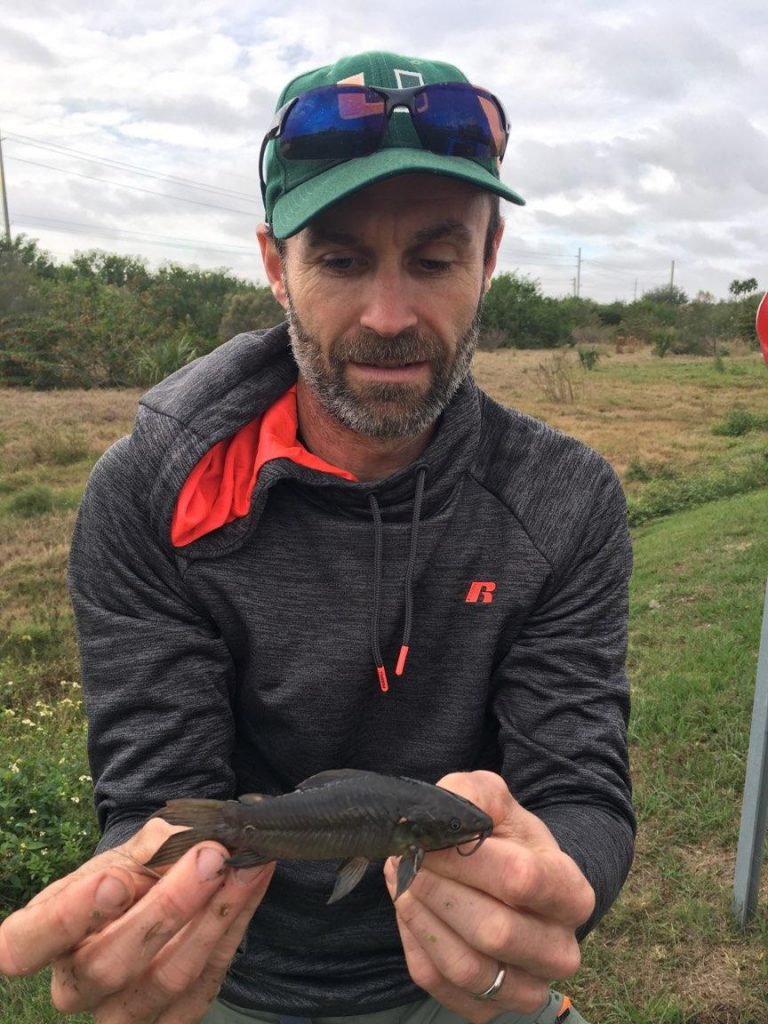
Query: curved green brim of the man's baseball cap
[[271, 147, 525, 239]]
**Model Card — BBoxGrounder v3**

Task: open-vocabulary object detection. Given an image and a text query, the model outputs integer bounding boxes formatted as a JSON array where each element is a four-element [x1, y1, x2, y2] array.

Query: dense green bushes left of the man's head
[[0, 236, 284, 388]]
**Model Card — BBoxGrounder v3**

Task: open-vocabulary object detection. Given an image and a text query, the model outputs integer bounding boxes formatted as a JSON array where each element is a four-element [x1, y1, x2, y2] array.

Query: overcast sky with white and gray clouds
[[0, 0, 768, 301]]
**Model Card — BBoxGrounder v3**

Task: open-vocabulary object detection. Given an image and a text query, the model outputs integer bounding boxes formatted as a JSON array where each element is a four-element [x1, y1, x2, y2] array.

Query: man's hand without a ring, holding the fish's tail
[[0, 819, 274, 1024]]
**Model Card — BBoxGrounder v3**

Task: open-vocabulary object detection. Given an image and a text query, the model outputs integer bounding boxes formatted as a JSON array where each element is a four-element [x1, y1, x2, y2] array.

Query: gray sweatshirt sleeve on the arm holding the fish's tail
[[69, 438, 234, 849]]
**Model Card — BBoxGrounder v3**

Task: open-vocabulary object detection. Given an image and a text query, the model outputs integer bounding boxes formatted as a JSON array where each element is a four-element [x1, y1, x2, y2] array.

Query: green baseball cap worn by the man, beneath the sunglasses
[[264, 51, 525, 239]]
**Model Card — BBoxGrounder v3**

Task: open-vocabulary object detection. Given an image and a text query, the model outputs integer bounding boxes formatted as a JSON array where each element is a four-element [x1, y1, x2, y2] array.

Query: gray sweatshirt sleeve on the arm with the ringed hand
[[494, 464, 635, 936]]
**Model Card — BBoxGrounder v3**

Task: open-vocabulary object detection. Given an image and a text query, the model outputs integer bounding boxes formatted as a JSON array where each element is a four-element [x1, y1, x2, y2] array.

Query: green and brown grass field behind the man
[[0, 351, 768, 1024]]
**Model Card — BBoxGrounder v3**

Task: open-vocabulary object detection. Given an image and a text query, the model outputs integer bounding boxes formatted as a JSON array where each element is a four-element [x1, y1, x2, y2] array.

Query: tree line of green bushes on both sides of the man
[[0, 234, 759, 388]]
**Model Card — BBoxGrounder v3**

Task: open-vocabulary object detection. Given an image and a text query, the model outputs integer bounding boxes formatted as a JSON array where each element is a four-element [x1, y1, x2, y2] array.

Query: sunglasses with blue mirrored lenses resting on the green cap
[[259, 82, 510, 201]]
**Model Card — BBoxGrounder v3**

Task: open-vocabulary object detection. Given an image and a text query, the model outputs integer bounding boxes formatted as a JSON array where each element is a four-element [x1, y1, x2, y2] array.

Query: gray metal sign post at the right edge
[[732, 588, 768, 928]]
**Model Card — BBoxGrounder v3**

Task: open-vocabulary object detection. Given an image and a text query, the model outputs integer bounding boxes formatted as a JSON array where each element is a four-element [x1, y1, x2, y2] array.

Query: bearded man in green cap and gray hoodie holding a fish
[[0, 53, 634, 1024]]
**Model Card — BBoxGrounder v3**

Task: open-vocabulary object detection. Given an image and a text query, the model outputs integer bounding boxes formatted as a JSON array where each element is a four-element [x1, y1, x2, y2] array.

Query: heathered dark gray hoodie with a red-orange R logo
[[70, 326, 634, 1015]]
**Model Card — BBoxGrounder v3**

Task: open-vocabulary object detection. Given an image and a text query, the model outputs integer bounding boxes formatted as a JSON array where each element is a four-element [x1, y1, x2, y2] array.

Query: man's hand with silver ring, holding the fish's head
[[385, 771, 595, 1024]]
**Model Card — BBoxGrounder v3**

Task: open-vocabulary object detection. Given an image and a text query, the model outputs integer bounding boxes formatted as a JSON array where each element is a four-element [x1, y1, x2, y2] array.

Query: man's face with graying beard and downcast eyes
[[268, 175, 501, 438]]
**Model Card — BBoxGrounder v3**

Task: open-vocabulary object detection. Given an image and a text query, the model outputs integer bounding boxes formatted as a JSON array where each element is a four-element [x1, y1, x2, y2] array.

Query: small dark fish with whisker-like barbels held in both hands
[[145, 768, 494, 903]]
